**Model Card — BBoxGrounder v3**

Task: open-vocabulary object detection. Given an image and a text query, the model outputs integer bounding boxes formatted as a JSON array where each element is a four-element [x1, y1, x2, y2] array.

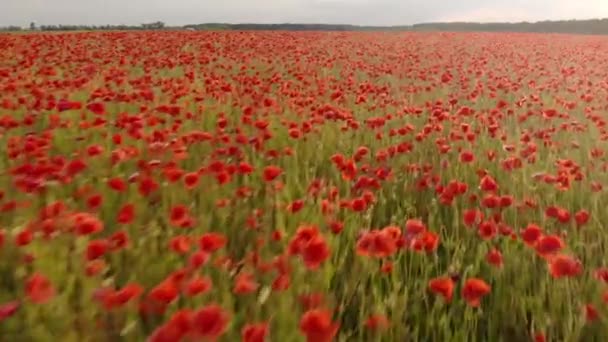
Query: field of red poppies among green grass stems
[[0, 31, 608, 342]]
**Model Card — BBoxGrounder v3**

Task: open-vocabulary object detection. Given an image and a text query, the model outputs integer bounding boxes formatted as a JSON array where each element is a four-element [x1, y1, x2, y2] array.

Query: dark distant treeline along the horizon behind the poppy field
[[0, 19, 608, 34]]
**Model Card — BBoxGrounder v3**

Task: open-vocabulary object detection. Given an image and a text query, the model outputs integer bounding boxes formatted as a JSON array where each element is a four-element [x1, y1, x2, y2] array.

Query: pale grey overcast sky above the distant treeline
[[0, 0, 608, 26]]
